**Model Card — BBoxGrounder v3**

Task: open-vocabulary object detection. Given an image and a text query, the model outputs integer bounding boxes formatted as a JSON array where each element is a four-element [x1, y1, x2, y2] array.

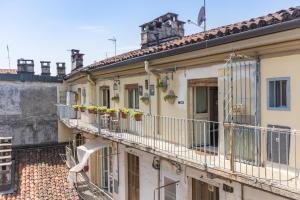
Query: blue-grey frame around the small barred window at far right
[[267, 77, 291, 111]]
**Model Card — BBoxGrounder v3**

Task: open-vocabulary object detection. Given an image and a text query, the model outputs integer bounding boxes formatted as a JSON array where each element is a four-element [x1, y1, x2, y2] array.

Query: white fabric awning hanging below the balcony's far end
[[68, 138, 109, 184]]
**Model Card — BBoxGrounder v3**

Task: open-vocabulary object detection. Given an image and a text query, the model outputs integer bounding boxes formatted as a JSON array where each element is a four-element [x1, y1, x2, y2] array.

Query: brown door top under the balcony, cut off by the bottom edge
[[192, 179, 219, 200]]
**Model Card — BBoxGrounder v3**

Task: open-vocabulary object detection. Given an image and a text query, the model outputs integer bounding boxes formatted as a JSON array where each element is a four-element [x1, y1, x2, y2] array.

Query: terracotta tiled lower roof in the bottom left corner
[[0, 145, 79, 200]]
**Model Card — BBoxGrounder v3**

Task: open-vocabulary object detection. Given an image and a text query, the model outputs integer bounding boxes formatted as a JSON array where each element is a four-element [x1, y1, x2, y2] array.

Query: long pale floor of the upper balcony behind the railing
[[62, 119, 300, 194]]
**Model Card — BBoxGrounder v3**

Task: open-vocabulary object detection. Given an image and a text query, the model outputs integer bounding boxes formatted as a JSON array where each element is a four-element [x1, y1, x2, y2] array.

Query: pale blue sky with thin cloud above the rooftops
[[0, 0, 300, 75]]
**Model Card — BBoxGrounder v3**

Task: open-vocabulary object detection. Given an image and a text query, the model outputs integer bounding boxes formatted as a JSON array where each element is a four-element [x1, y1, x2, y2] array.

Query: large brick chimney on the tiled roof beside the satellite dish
[[140, 13, 185, 48]]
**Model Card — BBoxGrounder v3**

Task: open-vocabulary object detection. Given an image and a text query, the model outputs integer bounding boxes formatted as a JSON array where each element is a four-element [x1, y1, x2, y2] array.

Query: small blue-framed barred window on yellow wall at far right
[[267, 78, 290, 110]]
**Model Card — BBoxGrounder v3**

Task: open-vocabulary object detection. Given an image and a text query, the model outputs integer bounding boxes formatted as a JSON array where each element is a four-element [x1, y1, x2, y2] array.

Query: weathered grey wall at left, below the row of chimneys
[[0, 81, 59, 145]]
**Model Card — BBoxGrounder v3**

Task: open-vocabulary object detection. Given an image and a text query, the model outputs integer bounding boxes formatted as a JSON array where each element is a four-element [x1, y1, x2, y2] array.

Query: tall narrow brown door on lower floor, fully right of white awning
[[127, 153, 140, 200]]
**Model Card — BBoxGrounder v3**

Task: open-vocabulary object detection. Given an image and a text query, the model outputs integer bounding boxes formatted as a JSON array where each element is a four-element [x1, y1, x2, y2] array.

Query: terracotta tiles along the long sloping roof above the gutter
[[67, 6, 300, 77]]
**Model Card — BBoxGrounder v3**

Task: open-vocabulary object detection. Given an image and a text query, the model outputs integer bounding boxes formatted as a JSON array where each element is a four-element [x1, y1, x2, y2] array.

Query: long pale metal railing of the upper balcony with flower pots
[[58, 106, 300, 191]]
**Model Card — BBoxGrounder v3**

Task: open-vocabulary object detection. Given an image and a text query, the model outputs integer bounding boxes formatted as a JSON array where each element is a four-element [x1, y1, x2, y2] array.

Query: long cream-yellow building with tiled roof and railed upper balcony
[[58, 7, 300, 200]]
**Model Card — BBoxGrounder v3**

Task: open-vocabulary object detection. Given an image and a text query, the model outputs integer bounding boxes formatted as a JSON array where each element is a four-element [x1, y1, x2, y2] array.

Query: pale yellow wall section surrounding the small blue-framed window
[[261, 54, 300, 166]]
